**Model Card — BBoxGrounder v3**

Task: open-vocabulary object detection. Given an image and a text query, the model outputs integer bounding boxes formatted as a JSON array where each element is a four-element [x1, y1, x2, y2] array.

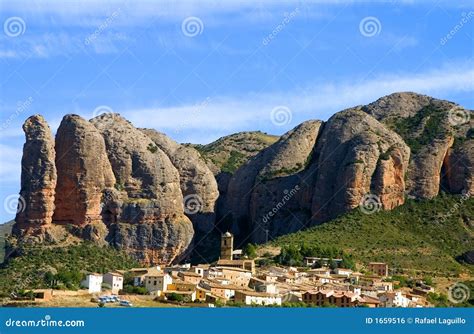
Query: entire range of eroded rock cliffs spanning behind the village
[[13, 93, 474, 256]]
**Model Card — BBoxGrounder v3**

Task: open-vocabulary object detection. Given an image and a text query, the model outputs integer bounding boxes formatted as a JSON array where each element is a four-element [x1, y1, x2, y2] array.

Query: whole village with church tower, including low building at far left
[[16, 232, 440, 307]]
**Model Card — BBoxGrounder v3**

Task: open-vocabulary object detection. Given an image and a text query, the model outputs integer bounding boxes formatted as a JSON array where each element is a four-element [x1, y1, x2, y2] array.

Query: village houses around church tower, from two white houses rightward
[[82, 232, 430, 307]]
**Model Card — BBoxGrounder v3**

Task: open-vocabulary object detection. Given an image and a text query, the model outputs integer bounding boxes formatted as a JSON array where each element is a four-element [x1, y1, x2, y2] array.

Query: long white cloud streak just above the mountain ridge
[[118, 62, 474, 142]]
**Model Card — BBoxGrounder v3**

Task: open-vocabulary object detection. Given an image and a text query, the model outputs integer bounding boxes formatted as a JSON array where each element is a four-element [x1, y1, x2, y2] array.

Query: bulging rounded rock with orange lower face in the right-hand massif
[[312, 108, 410, 222]]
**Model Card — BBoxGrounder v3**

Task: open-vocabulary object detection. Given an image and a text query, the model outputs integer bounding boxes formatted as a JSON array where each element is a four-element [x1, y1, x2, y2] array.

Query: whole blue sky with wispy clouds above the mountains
[[0, 0, 474, 221]]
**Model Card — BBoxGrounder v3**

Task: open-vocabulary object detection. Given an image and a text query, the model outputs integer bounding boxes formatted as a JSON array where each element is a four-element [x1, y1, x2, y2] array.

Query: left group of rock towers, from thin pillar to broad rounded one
[[14, 114, 194, 265]]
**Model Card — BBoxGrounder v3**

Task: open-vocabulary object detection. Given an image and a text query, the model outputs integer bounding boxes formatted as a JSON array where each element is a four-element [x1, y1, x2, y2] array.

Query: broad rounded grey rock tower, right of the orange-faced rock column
[[91, 114, 194, 264]]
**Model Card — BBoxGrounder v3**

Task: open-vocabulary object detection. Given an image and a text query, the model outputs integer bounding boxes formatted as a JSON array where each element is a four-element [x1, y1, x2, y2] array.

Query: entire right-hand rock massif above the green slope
[[223, 93, 474, 242]]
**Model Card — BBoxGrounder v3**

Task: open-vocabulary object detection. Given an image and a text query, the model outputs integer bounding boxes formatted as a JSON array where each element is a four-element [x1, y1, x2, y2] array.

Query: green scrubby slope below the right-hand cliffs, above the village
[[270, 195, 474, 274]]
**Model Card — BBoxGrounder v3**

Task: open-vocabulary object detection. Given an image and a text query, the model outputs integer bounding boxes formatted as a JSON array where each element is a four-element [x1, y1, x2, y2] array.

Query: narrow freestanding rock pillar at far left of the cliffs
[[13, 115, 57, 241]]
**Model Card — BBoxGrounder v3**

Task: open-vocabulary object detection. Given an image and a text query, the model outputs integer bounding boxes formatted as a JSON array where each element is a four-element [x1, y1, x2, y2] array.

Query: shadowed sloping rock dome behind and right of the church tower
[[223, 121, 322, 242]]
